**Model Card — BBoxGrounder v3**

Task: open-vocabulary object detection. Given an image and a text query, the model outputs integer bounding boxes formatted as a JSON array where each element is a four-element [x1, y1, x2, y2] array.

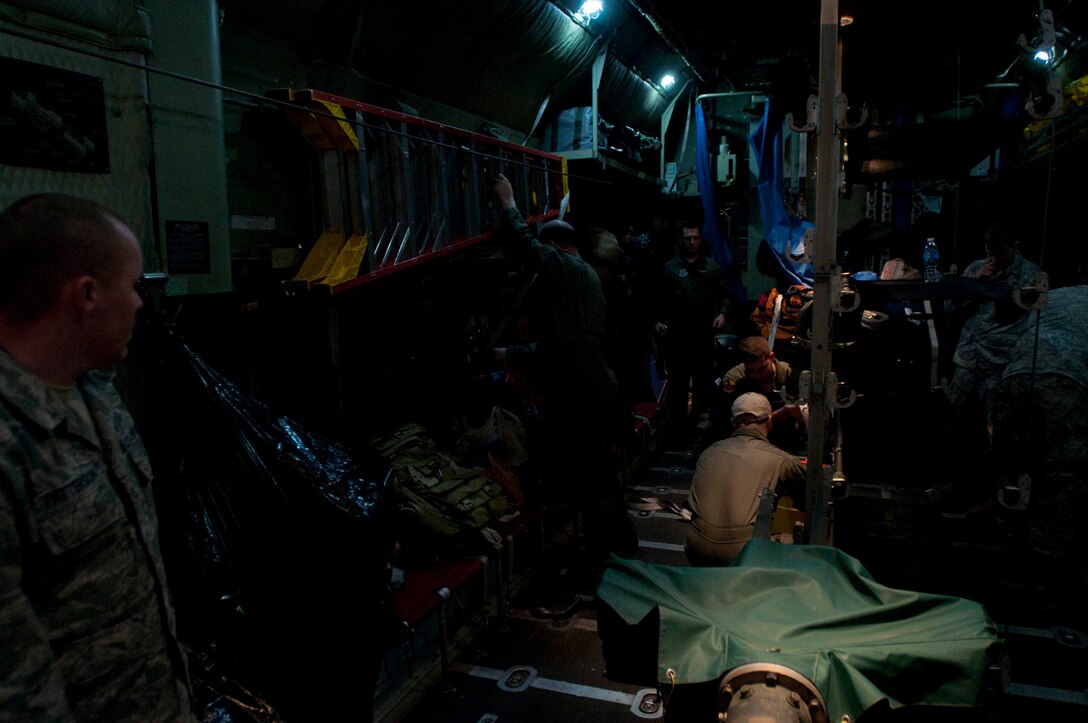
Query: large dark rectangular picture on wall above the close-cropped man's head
[[0, 58, 110, 173]]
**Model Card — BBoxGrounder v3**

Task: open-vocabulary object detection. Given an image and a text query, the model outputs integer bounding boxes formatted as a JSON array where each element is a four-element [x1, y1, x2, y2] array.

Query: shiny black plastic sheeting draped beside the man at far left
[[137, 328, 395, 723]]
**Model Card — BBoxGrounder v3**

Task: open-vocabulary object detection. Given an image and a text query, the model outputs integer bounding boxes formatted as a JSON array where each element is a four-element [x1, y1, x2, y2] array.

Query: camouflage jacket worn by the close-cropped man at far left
[[0, 350, 193, 722]]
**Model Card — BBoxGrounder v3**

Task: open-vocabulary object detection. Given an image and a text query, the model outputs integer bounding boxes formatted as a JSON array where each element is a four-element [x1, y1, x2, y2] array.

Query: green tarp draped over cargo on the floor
[[597, 539, 1001, 721]]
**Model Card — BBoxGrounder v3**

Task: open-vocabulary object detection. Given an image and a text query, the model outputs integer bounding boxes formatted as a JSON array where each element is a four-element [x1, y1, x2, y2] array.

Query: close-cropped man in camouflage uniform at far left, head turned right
[[0, 194, 195, 723]]
